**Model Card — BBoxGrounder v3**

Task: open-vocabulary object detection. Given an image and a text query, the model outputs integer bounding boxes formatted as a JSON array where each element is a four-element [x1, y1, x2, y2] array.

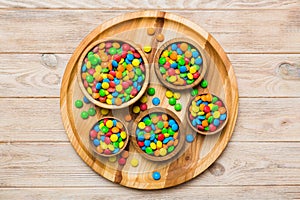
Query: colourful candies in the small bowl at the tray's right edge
[[188, 94, 227, 132]]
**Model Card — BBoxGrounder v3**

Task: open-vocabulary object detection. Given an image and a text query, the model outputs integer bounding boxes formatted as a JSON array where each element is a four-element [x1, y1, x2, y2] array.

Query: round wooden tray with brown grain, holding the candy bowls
[[60, 11, 238, 189]]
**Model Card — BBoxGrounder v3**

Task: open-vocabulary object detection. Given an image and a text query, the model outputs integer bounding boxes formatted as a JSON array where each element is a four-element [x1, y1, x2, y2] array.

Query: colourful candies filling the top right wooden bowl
[[158, 42, 202, 86]]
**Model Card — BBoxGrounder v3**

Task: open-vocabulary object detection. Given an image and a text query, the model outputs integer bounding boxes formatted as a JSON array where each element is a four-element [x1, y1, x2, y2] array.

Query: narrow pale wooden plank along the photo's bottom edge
[[0, 185, 300, 200]]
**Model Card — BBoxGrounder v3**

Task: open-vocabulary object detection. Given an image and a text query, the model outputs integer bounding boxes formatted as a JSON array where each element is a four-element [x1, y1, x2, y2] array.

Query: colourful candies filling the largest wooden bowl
[[81, 41, 145, 106]]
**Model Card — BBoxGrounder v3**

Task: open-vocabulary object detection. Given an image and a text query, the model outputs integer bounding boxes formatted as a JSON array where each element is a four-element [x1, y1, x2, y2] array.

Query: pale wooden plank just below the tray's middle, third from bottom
[[0, 98, 300, 142]]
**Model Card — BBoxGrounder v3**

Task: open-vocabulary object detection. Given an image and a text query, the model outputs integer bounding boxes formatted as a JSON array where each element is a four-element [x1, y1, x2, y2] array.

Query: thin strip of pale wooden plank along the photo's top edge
[[0, 0, 299, 10]]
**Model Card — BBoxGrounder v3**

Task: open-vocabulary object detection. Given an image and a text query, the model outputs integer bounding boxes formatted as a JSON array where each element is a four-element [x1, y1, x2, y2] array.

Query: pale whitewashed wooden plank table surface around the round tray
[[0, 0, 300, 199]]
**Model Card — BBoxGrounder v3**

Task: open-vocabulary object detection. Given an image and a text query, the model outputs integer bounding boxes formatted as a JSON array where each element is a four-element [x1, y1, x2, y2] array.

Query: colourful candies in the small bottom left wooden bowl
[[90, 118, 127, 155]]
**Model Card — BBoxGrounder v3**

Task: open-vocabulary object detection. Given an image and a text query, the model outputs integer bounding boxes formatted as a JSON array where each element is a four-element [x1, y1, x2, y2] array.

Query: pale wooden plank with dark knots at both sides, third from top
[[0, 54, 300, 97]]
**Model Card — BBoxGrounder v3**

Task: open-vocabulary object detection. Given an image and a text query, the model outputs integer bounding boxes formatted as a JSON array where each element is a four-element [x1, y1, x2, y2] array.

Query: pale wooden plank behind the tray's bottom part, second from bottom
[[0, 142, 300, 187]]
